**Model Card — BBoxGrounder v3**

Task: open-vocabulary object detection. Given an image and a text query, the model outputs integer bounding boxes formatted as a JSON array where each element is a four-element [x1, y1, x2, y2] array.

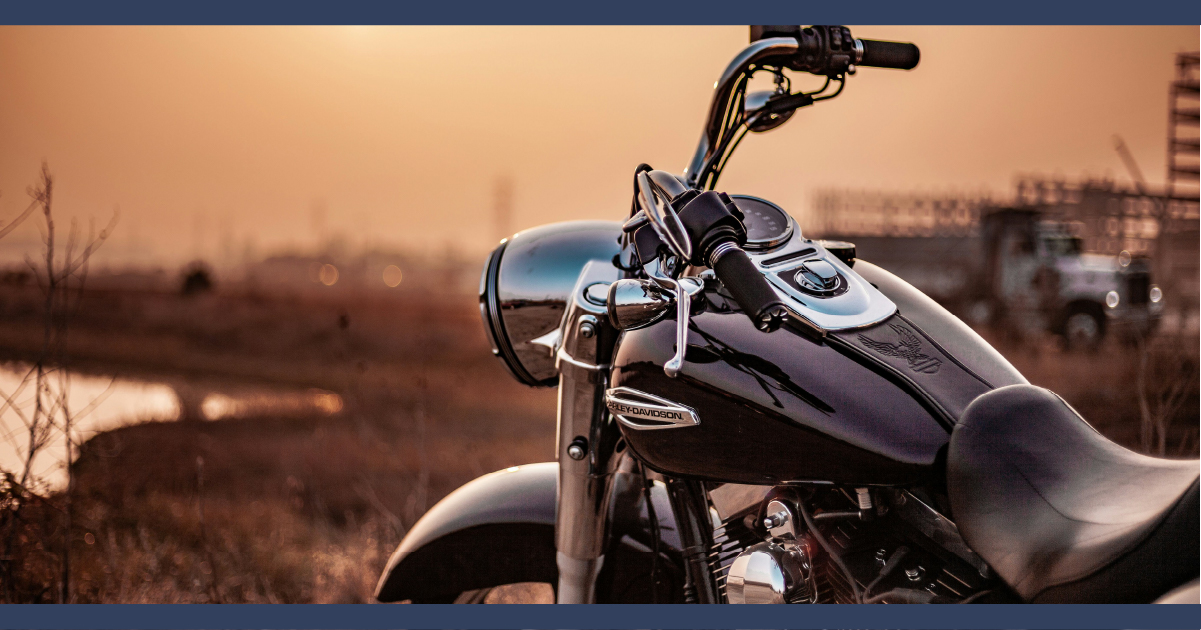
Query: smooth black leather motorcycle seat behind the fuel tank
[[946, 385, 1199, 604]]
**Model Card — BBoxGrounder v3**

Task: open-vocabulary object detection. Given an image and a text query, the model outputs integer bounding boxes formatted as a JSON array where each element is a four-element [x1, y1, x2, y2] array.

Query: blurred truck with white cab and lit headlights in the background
[[824, 208, 1164, 350]]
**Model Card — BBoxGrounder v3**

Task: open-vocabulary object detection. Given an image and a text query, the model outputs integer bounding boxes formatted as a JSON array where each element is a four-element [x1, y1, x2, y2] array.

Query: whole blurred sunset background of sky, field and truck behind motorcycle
[[0, 26, 1199, 602]]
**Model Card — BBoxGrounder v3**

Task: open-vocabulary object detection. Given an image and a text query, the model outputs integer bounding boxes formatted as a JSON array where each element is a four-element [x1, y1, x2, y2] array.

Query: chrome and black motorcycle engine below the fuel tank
[[710, 484, 1003, 604]]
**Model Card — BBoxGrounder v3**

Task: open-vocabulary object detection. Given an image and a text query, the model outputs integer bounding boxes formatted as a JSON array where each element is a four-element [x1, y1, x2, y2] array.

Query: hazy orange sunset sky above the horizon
[[0, 26, 1199, 264]]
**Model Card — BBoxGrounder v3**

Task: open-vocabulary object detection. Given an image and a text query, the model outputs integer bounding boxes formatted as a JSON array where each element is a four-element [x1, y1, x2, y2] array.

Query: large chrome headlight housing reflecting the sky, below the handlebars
[[479, 221, 621, 386]]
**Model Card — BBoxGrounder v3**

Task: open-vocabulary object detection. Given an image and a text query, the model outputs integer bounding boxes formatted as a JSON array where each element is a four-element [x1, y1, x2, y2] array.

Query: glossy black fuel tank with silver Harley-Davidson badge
[[610, 262, 1024, 485]]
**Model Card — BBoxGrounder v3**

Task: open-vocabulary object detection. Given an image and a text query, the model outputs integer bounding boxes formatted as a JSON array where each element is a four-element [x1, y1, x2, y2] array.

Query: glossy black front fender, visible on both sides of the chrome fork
[[376, 462, 683, 604]]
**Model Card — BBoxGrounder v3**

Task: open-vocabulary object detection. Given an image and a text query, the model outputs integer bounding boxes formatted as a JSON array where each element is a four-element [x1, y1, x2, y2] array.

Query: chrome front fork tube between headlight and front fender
[[555, 262, 619, 604]]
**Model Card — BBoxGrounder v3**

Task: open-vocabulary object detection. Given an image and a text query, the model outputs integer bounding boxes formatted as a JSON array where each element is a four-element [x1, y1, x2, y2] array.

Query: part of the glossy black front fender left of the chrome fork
[[376, 462, 558, 602]]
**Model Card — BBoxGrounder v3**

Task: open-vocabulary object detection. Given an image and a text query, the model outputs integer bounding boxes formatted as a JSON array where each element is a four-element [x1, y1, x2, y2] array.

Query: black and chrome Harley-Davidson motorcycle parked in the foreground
[[376, 26, 1199, 604]]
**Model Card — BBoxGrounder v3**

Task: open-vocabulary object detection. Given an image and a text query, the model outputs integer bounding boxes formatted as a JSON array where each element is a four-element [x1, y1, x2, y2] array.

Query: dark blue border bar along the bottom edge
[[0, 604, 1201, 630]]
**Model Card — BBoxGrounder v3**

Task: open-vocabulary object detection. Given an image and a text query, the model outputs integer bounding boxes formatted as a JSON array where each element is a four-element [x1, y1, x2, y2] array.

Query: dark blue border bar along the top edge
[[0, 0, 1201, 24]]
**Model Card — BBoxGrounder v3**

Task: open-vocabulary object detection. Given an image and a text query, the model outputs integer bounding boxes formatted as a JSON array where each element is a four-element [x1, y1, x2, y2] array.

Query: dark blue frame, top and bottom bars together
[[0, 0, 1201, 630]]
